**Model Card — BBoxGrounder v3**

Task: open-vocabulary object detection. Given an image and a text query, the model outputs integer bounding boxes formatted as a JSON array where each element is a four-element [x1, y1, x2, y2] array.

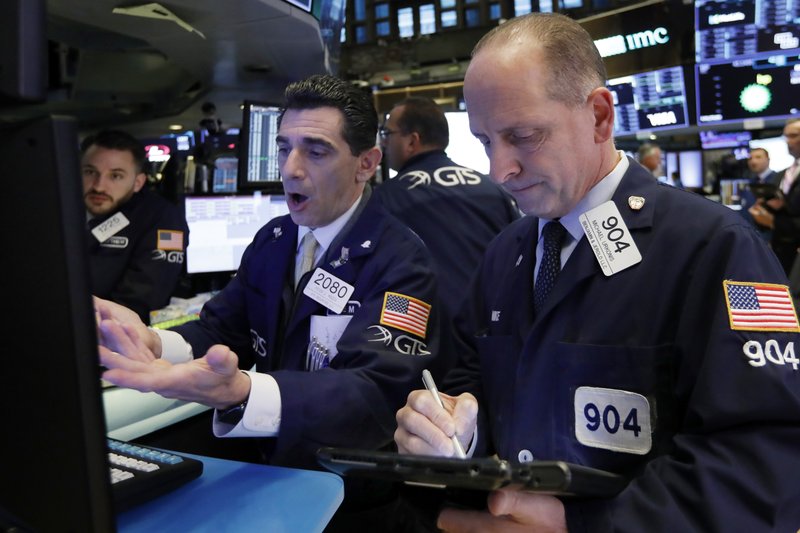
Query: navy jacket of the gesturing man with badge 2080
[[175, 193, 442, 468]]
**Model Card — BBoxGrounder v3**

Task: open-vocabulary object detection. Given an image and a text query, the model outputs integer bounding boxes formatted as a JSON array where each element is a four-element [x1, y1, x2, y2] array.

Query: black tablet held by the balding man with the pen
[[317, 448, 627, 497]]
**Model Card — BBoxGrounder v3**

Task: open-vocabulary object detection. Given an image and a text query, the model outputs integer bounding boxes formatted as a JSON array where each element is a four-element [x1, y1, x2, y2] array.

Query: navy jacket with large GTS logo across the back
[[375, 150, 520, 314]]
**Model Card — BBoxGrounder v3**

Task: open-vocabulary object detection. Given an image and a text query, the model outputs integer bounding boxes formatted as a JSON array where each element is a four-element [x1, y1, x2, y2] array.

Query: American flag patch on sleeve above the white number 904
[[723, 281, 800, 331]]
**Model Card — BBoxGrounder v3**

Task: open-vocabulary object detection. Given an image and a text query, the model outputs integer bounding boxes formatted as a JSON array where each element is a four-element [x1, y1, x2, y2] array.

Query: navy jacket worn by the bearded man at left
[[86, 189, 189, 324]]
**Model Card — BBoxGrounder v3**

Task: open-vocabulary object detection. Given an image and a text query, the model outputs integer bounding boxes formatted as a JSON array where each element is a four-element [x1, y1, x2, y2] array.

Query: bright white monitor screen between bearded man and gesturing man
[[184, 192, 289, 274]]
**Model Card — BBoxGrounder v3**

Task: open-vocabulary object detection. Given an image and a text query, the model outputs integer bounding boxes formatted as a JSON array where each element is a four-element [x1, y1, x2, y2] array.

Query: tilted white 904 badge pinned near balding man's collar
[[580, 200, 642, 276]]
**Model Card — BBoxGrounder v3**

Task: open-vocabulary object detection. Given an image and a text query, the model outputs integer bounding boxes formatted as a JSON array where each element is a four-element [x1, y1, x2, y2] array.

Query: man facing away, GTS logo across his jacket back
[[376, 97, 520, 314]]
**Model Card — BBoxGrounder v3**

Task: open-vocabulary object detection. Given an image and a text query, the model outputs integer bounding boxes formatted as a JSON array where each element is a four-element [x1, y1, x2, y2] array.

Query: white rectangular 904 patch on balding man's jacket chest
[[575, 387, 653, 455]]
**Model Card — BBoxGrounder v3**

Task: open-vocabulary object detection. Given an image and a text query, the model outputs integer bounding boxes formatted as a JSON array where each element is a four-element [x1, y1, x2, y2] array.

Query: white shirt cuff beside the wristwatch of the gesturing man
[[213, 370, 281, 437]]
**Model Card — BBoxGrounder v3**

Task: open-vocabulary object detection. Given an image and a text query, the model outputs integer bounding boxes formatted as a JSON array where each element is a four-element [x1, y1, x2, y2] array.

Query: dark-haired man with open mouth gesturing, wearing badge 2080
[[97, 75, 442, 516]]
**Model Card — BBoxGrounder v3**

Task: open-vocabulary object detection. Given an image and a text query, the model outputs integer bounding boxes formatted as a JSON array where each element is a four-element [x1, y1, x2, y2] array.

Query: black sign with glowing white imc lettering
[[580, 1, 694, 78]]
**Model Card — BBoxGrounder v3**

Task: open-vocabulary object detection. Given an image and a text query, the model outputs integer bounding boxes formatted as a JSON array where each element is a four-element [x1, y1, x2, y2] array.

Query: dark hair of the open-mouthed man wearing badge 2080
[[278, 74, 378, 156]]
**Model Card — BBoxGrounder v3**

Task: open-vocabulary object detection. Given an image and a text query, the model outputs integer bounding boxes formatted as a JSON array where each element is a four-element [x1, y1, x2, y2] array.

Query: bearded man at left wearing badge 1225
[[81, 130, 189, 323]]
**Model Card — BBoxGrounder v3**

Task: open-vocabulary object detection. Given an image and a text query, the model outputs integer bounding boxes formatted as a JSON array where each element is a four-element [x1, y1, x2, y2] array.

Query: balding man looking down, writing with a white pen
[[395, 13, 800, 533]]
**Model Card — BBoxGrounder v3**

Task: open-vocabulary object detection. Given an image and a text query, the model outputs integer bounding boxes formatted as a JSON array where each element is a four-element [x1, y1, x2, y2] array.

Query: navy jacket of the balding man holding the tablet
[[441, 160, 800, 533]]
